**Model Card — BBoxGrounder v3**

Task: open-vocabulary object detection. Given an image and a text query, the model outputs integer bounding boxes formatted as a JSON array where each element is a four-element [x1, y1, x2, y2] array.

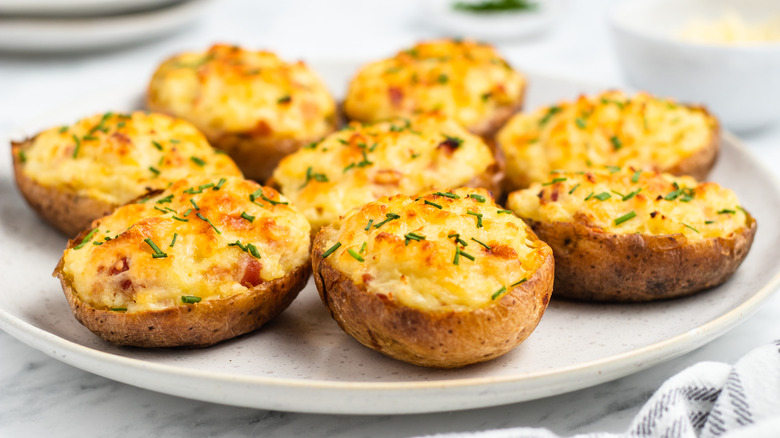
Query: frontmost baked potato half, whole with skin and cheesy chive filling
[[312, 188, 554, 368]]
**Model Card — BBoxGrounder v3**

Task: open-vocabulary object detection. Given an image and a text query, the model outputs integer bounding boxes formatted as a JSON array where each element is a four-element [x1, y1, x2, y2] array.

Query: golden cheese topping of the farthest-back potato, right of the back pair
[[344, 40, 526, 130]]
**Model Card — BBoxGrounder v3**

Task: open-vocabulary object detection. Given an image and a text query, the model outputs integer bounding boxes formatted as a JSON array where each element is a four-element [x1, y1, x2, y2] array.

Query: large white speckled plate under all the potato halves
[[0, 63, 780, 414]]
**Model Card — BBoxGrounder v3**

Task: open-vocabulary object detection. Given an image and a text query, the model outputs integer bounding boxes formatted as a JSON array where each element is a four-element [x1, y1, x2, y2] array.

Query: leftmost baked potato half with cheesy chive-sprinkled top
[[11, 111, 241, 237]]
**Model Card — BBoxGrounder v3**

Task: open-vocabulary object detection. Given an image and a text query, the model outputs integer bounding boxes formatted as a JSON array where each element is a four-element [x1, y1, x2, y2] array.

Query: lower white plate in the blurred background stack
[[0, 0, 211, 53]]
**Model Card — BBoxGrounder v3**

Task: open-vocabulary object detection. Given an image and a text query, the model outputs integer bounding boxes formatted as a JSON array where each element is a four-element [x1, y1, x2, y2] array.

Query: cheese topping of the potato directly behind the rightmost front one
[[497, 91, 717, 187]]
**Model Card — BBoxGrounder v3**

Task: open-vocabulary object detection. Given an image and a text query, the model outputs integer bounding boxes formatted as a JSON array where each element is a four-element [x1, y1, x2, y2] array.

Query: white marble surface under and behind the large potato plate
[[0, 0, 780, 437]]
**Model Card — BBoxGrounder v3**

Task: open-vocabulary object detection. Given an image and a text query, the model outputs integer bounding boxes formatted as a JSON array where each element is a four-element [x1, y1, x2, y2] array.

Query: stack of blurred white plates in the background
[[0, 0, 210, 53]]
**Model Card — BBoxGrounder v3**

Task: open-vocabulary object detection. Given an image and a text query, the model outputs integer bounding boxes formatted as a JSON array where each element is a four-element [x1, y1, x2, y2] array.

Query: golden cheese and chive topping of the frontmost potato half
[[323, 188, 552, 311]]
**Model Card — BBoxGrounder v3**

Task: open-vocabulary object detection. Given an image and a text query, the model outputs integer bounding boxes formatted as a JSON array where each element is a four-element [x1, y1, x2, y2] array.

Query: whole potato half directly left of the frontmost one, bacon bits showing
[[54, 176, 311, 347]]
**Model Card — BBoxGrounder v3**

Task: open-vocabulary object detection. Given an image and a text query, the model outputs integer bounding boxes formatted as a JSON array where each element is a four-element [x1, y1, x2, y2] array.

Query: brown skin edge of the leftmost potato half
[[11, 137, 118, 237]]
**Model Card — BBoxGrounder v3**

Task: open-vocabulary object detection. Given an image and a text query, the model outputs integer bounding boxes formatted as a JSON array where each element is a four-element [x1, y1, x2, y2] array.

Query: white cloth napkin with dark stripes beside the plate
[[420, 341, 780, 438]]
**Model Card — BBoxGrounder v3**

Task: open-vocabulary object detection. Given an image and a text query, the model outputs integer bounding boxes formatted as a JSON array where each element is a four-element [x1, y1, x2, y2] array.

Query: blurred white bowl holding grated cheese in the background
[[610, 0, 780, 131]]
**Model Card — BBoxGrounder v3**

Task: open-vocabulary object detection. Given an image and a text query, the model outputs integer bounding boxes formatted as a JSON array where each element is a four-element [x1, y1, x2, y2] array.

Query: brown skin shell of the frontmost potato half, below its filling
[[312, 227, 555, 368]]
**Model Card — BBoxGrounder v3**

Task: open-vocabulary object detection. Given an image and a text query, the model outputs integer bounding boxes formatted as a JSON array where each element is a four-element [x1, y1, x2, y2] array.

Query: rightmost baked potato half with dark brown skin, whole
[[508, 168, 756, 301]]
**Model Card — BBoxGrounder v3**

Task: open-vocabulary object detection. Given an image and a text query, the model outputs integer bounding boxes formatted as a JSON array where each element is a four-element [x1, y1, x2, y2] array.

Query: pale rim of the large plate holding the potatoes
[[0, 70, 780, 414]]
